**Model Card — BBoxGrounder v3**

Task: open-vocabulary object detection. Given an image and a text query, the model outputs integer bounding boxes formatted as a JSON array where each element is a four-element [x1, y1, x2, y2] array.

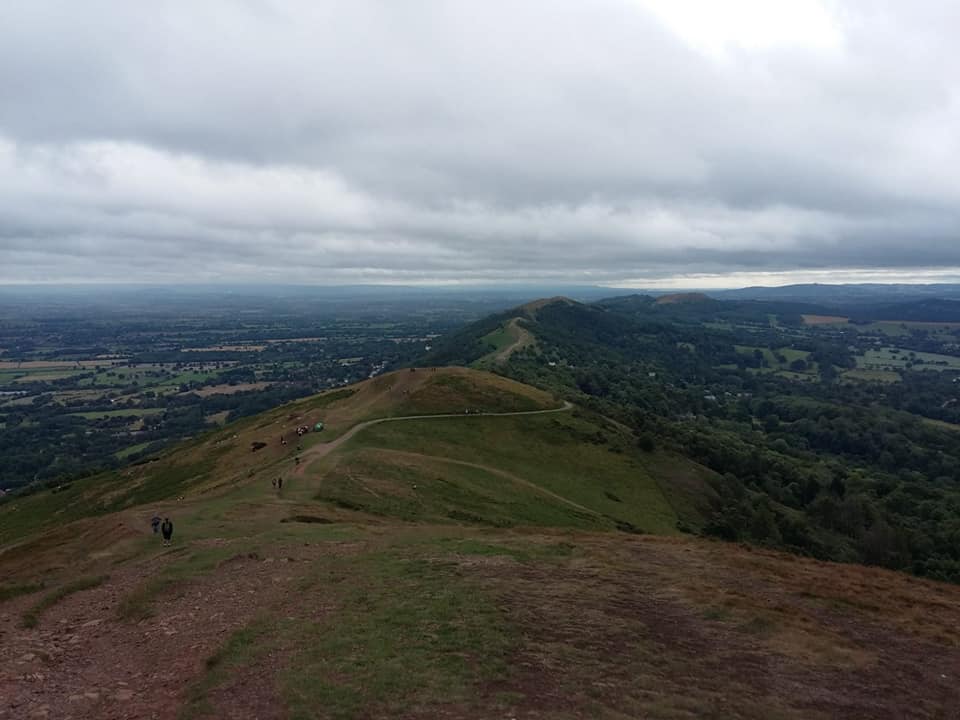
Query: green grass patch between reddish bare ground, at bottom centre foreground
[[280, 552, 518, 720]]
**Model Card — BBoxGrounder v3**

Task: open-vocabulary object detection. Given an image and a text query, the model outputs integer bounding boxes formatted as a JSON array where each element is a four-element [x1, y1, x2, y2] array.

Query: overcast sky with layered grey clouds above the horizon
[[0, 0, 960, 287]]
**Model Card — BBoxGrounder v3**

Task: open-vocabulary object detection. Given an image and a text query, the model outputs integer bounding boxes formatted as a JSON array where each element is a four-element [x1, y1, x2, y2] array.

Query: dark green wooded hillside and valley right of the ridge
[[438, 295, 960, 582]]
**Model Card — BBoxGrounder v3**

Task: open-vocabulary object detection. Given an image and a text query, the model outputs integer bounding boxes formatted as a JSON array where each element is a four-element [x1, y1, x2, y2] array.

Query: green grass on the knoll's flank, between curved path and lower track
[[338, 413, 677, 534]]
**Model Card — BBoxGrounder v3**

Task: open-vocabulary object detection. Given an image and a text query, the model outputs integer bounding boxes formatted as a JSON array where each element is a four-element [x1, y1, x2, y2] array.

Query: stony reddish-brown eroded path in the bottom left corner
[[0, 540, 356, 720]]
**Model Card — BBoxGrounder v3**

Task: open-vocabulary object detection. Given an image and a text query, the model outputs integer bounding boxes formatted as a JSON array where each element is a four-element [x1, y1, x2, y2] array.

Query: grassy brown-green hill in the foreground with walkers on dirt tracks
[[0, 368, 960, 719]]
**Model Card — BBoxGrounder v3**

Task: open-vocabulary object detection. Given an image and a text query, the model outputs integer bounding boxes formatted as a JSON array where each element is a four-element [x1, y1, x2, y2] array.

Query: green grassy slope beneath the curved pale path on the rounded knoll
[[321, 414, 677, 533]]
